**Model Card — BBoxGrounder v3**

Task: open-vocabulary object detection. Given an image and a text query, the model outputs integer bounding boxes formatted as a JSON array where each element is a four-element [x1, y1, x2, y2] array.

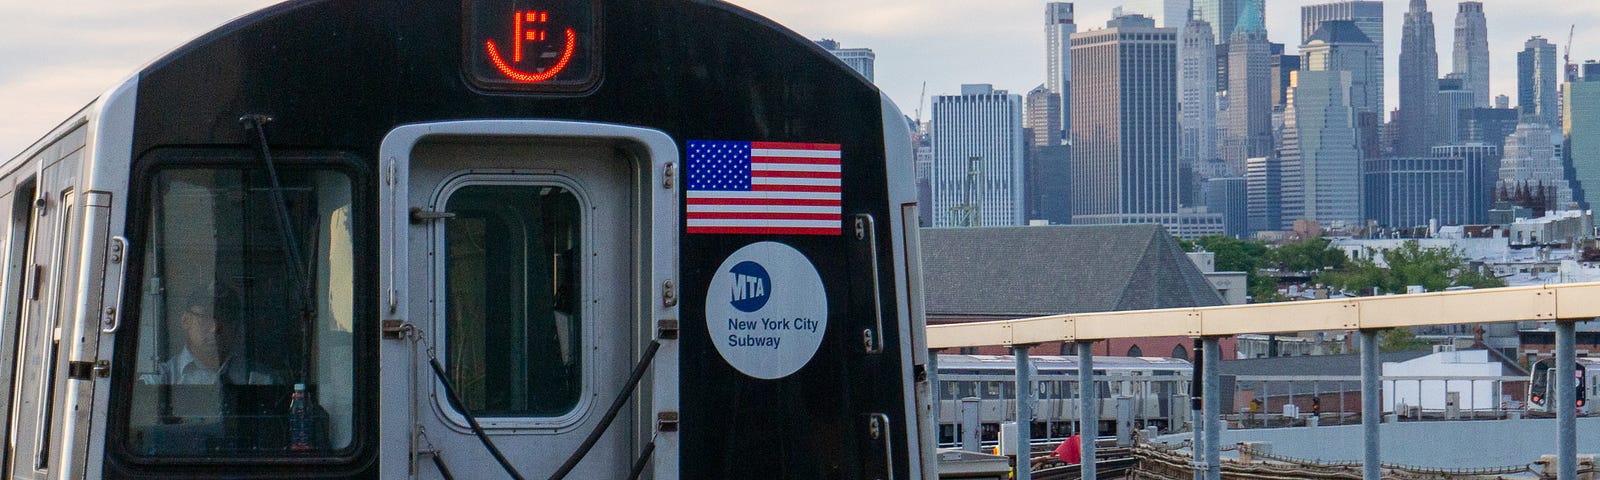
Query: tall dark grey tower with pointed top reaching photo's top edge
[[1395, 0, 1440, 157]]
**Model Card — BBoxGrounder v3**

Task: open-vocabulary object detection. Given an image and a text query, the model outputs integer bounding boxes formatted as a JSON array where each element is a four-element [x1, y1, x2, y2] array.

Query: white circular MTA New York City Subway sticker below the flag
[[706, 242, 827, 379]]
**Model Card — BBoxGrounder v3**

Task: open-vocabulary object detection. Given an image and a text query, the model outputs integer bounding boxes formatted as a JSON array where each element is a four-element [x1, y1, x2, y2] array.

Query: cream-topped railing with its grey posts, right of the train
[[928, 283, 1600, 480]]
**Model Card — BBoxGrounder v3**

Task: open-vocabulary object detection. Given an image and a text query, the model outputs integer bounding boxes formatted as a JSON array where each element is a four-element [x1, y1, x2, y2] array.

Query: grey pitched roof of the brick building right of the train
[[922, 224, 1222, 318]]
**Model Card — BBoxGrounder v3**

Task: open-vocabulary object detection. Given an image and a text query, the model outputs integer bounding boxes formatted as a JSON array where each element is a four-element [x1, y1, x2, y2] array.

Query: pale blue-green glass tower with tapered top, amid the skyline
[[1282, 70, 1362, 226]]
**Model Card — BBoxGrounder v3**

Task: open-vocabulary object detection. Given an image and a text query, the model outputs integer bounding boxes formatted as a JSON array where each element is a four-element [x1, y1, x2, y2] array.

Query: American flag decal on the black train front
[[685, 141, 842, 235]]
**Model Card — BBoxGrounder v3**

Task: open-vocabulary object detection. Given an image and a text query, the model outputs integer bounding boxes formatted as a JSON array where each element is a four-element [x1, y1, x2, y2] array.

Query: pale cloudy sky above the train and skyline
[[0, 0, 1600, 158]]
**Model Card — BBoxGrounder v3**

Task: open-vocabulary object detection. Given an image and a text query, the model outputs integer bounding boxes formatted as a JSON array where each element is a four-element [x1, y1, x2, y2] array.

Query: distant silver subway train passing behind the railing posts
[[938, 355, 1194, 442]]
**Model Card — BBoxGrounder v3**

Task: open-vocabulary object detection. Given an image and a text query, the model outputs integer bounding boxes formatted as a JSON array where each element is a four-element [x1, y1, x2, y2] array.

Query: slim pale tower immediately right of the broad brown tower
[[1178, 19, 1216, 198]]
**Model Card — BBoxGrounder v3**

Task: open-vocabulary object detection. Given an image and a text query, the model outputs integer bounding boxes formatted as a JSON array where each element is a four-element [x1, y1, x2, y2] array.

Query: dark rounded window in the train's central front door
[[443, 184, 584, 418]]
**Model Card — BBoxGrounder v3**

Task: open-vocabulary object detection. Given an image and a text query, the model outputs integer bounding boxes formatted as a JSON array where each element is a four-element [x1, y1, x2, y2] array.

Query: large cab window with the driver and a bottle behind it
[[125, 165, 355, 458]]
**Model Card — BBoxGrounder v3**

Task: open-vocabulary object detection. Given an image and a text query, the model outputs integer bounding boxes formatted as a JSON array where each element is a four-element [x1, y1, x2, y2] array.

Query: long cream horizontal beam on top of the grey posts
[[928, 283, 1600, 349]]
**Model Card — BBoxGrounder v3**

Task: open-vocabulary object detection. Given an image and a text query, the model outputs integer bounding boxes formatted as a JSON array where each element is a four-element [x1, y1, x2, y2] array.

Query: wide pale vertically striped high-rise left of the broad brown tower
[[931, 85, 1026, 227]]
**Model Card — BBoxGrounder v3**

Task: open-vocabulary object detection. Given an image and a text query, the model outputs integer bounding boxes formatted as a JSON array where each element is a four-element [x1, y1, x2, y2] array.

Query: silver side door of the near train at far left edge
[[6, 141, 83, 478]]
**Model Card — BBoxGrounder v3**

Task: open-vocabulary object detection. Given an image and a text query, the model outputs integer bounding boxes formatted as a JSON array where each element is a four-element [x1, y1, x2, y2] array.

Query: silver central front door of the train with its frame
[[381, 122, 675, 478]]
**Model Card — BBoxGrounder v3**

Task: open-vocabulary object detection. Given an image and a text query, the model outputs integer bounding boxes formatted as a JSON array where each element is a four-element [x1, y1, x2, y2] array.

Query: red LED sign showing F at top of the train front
[[462, 0, 600, 91]]
